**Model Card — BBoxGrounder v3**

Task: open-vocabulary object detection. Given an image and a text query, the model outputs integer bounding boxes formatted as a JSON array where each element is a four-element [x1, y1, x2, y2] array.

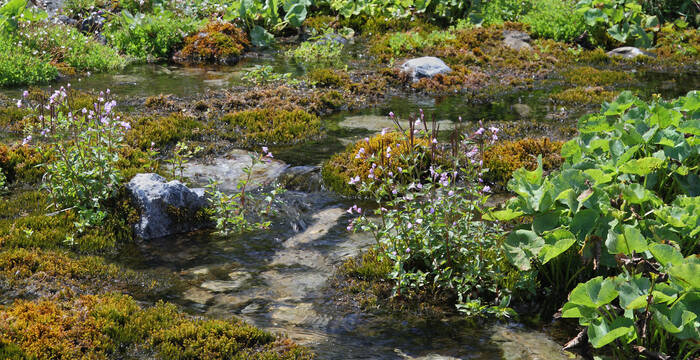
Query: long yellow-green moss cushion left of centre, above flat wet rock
[[221, 109, 321, 147]]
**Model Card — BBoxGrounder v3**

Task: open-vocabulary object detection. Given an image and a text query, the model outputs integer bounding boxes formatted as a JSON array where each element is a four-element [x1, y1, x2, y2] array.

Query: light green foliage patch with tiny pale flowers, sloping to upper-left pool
[[19, 22, 125, 71]]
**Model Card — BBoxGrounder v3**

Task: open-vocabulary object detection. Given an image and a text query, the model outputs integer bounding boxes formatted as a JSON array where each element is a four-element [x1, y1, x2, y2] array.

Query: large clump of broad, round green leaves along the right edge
[[493, 91, 700, 358]]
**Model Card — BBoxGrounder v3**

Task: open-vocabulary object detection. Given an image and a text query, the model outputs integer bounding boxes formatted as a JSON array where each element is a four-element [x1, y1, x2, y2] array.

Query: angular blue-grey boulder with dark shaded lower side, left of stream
[[126, 173, 207, 239]]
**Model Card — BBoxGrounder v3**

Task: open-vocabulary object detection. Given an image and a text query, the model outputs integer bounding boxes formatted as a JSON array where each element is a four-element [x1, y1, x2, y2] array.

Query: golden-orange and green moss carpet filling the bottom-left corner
[[0, 294, 311, 360]]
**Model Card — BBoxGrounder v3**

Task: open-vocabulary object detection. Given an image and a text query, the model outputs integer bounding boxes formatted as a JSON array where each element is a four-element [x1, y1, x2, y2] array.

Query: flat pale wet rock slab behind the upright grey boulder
[[183, 150, 289, 192]]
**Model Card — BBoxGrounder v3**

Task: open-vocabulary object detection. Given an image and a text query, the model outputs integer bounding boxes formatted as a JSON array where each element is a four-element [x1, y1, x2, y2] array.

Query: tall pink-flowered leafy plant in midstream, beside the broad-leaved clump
[[348, 114, 516, 317]]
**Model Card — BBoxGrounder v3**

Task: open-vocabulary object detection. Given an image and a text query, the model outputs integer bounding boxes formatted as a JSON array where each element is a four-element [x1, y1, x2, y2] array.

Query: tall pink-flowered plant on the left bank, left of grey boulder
[[17, 84, 130, 227]]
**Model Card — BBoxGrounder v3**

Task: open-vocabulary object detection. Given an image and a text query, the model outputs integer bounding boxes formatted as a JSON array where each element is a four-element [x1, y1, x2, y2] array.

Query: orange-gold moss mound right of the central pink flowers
[[484, 138, 563, 187]]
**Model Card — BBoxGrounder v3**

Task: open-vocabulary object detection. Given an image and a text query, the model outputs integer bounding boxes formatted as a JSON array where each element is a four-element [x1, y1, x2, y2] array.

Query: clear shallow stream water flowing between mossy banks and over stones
[[5, 50, 700, 359]]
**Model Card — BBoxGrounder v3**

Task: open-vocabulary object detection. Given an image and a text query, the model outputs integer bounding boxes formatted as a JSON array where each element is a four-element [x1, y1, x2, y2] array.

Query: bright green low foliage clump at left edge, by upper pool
[[0, 36, 58, 86]]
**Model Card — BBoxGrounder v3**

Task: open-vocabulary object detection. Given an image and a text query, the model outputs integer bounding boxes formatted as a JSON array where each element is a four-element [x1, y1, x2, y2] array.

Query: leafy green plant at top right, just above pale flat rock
[[577, 0, 659, 48]]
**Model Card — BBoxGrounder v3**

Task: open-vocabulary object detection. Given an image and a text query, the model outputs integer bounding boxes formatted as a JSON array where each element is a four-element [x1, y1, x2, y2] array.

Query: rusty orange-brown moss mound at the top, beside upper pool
[[174, 21, 250, 65]]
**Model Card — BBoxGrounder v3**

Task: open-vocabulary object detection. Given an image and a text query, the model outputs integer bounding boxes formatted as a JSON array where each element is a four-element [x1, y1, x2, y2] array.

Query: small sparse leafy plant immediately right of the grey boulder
[[207, 147, 284, 236]]
